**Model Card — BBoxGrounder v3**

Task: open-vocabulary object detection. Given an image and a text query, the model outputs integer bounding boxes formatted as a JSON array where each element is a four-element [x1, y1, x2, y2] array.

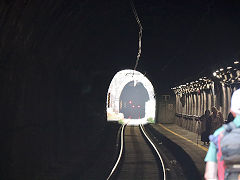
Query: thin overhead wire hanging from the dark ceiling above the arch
[[130, 0, 143, 70]]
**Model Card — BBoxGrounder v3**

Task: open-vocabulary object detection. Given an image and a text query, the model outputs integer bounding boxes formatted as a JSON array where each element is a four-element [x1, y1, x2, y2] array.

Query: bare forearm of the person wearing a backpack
[[204, 161, 217, 180]]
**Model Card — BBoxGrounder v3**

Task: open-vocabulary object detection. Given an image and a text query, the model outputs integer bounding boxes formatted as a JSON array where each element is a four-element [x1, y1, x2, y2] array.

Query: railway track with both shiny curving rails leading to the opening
[[107, 125, 166, 180]]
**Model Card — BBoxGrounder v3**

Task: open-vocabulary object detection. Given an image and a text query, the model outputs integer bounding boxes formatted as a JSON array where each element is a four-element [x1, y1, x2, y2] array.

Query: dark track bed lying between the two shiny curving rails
[[115, 126, 162, 180]]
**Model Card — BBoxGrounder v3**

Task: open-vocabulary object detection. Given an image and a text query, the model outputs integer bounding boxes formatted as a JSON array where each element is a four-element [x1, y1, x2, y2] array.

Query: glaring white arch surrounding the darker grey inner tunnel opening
[[106, 69, 156, 124]]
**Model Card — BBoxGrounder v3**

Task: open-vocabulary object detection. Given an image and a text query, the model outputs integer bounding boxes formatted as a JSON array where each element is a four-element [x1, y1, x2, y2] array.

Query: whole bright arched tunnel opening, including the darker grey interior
[[106, 69, 156, 125]]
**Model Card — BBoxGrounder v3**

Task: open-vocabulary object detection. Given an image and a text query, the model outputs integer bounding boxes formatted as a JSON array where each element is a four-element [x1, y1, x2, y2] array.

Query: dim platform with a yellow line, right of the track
[[151, 124, 208, 179]]
